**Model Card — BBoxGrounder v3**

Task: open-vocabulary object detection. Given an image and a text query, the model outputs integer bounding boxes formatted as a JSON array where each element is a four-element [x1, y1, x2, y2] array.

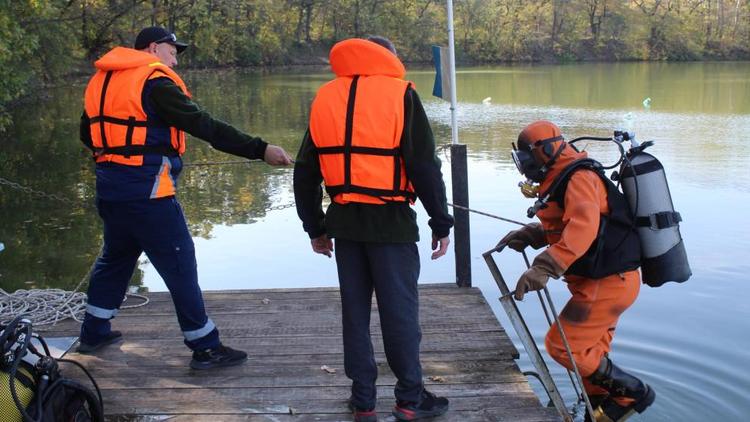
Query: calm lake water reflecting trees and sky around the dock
[[0, 63, 750, 421]]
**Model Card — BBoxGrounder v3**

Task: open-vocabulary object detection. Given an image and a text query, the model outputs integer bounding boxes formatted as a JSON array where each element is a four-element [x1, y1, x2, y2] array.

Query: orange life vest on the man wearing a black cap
[[85, 47, 190, 166]]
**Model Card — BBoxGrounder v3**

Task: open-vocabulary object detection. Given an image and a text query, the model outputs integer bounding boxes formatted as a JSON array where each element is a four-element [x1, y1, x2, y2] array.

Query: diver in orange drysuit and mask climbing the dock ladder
[[501, 120, 655, 421]]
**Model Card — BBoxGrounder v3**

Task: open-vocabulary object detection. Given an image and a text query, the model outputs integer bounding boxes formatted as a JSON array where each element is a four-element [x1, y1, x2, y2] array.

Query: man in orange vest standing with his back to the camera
[[294, 37, 453, 421]]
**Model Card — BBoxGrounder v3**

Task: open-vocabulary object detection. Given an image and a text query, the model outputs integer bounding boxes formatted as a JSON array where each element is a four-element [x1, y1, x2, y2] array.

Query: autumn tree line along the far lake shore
[[0, 0, 750, 131]]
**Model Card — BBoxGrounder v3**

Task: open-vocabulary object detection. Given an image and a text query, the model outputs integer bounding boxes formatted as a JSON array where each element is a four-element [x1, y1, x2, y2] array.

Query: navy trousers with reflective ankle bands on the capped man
[[81, 197, 220, 350]]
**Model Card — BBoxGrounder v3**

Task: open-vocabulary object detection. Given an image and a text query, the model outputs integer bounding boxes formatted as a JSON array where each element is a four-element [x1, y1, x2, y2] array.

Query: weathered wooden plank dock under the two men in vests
[[43, 284, 560, 422]]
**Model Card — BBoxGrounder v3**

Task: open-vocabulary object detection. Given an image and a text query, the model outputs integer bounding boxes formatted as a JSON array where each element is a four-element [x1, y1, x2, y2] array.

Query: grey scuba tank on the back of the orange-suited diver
[[613, 131, 692, 287]]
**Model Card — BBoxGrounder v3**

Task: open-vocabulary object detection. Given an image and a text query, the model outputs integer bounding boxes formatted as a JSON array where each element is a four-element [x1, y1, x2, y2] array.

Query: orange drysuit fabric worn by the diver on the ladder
[[537, 141, 640, 401]]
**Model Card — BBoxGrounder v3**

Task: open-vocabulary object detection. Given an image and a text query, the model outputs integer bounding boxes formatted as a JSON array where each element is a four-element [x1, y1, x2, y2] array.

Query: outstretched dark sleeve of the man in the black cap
[[148, 78, 268, 159]]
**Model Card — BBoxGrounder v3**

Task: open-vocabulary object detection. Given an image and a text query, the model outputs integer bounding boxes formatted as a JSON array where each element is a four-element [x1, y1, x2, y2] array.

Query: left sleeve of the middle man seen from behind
[[294, 129, 326, 239]]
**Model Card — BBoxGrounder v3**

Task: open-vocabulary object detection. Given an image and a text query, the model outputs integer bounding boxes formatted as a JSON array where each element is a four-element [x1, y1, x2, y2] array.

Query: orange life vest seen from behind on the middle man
[[310, 39, 415, 204]]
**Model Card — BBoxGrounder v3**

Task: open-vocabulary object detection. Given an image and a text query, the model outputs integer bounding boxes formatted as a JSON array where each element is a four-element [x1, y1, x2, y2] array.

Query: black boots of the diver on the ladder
[[589, 356, 656, 422]]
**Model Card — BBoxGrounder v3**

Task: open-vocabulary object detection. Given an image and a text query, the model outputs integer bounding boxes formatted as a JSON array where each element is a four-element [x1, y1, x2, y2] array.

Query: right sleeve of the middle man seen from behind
[[401, 88, 453, 238]]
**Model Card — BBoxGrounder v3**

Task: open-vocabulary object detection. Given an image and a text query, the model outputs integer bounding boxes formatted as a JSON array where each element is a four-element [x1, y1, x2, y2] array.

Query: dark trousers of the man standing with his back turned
[[335, 239, 424, 409]]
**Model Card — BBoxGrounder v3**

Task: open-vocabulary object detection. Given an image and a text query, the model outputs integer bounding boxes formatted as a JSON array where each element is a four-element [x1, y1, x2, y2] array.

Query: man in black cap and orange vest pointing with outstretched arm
[[78, 27, 291, 369]]
